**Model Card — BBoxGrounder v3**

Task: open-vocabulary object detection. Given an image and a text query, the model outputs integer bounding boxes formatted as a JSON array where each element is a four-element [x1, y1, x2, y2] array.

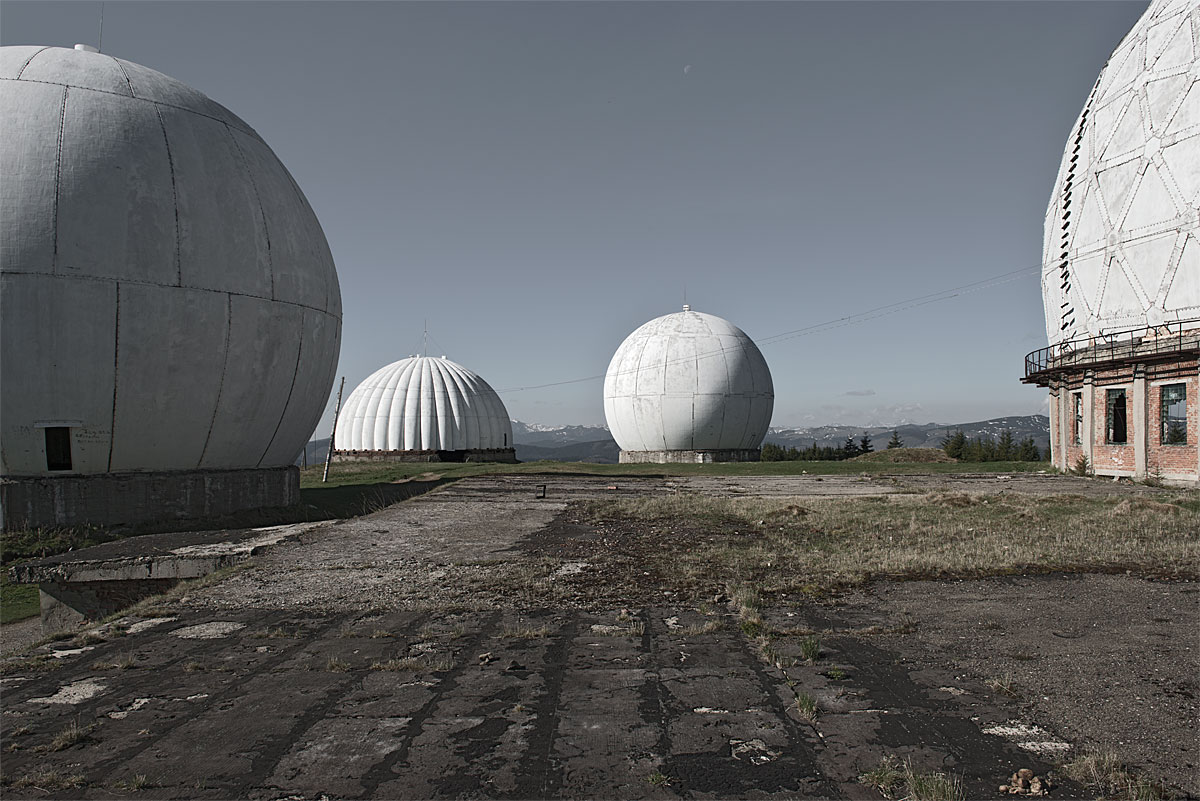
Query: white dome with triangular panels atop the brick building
[[1042, 0, 1200, 344]]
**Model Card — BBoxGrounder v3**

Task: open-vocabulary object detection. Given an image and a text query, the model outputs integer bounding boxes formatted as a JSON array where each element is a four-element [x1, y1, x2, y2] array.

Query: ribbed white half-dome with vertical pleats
[[334, 356, 512, 451]]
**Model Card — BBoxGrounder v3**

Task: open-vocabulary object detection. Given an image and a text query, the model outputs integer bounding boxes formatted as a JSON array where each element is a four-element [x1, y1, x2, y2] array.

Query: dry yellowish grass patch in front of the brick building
[[586, 492, 1200, 594]]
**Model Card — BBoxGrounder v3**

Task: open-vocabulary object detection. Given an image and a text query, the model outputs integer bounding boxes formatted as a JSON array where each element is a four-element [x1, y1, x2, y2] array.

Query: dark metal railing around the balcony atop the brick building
[[1022, 318, 1200, 384]]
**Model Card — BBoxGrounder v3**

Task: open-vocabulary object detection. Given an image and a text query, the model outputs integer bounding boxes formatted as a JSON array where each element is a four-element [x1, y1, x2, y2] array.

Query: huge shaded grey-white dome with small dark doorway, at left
[[0, 47, 342, 475]]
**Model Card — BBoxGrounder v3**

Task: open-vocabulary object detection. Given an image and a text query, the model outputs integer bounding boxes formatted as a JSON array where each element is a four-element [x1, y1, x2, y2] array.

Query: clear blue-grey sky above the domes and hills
[[0, 0, 1147, 436]]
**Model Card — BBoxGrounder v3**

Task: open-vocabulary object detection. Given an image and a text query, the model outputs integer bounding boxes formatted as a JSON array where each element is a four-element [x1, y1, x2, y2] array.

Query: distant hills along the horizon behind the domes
[[296, 415, 1050, 464]]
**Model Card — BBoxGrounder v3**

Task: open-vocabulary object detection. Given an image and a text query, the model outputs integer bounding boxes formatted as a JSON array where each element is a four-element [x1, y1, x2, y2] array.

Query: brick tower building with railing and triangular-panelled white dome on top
[[1024, 0, 1200, 482]]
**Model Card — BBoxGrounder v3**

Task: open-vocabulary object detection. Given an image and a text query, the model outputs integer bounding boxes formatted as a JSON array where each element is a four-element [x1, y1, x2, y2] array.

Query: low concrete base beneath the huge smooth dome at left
[[0, 465, 300, 531]]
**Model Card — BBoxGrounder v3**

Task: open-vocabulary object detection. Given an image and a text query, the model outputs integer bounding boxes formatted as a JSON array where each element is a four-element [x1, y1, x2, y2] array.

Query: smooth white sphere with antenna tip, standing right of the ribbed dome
[[604, 307, 775, 451]]
